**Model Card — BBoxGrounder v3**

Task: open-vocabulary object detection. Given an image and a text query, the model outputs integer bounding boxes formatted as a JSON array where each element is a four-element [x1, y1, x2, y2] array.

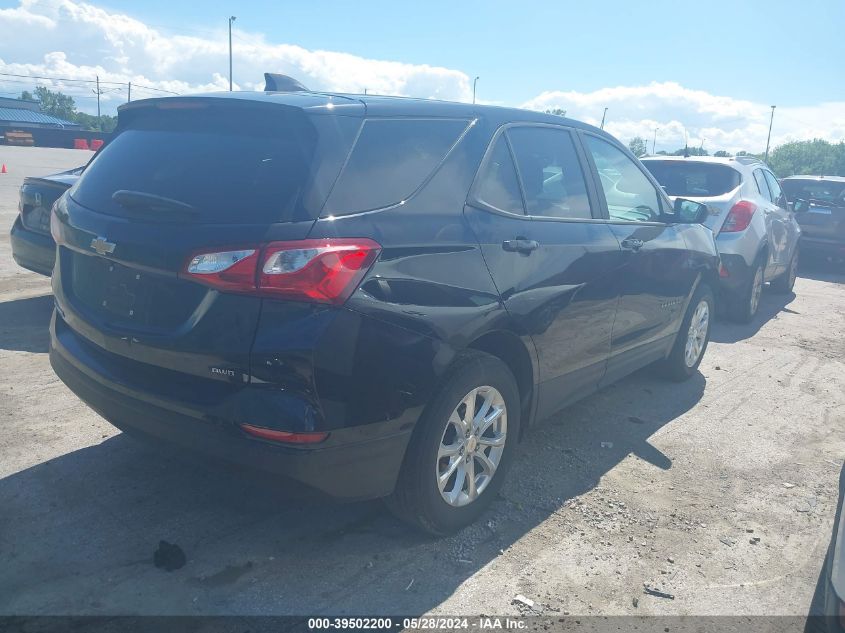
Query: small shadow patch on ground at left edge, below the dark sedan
[[0, 294, 53, 354]]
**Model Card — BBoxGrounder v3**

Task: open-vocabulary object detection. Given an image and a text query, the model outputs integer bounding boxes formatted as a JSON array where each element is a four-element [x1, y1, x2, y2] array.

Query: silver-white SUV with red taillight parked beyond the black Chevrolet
[[641, 156, 801, 323]]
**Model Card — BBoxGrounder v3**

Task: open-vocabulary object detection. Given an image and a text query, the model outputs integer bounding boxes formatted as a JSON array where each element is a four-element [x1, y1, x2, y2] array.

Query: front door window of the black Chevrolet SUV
[[585, 135, 660, 222]]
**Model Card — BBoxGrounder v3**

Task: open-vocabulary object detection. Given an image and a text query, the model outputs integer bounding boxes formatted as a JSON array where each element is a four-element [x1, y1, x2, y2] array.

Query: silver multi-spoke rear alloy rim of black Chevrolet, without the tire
[[435, 386, 508, 507]]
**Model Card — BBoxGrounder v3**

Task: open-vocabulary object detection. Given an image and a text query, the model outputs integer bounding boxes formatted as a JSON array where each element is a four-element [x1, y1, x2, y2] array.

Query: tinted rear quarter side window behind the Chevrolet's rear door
[[323, 119, 469, 216]]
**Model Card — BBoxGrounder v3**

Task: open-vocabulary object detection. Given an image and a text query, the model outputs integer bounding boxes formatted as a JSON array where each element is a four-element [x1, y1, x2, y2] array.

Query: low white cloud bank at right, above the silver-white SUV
[[522, 82, 845, 152]]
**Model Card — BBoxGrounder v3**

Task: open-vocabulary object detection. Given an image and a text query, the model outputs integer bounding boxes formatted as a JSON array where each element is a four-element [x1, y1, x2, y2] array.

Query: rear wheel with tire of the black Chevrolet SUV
[[385, 351, 520, 536]]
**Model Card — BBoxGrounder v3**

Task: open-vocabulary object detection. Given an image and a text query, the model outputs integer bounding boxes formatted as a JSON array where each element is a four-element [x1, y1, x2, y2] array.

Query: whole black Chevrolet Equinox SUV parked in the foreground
[[50, 91, 718, 534]]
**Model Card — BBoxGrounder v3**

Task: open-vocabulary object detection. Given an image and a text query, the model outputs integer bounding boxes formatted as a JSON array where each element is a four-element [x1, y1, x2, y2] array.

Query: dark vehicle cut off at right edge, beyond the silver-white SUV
[[781, 176, 845, 260]]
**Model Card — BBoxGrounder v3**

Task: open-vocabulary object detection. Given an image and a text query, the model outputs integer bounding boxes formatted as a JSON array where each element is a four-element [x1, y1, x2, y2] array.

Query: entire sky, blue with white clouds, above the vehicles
[[0, 0, 845, 152]]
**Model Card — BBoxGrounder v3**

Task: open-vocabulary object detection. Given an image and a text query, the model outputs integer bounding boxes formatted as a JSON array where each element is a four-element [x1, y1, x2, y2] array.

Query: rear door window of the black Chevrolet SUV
[[507, 127, 593, 219]]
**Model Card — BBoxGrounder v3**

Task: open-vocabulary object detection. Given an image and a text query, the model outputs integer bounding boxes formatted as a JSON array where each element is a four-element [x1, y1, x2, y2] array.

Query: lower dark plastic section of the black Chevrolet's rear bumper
[[50, 312, 411, 499]]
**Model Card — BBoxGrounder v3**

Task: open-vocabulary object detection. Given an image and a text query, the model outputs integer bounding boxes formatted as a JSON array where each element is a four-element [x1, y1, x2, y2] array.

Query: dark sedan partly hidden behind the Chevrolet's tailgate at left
[[11, 167, 83, 277]]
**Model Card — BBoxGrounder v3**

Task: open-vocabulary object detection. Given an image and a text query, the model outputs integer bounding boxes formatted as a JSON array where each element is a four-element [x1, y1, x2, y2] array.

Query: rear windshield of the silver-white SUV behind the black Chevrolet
[[643, 160, 742, 198]]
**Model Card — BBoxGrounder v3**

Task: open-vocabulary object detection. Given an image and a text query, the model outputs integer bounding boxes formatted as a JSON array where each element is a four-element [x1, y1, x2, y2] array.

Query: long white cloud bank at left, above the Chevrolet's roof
[[0, 0, 471, 105]]
